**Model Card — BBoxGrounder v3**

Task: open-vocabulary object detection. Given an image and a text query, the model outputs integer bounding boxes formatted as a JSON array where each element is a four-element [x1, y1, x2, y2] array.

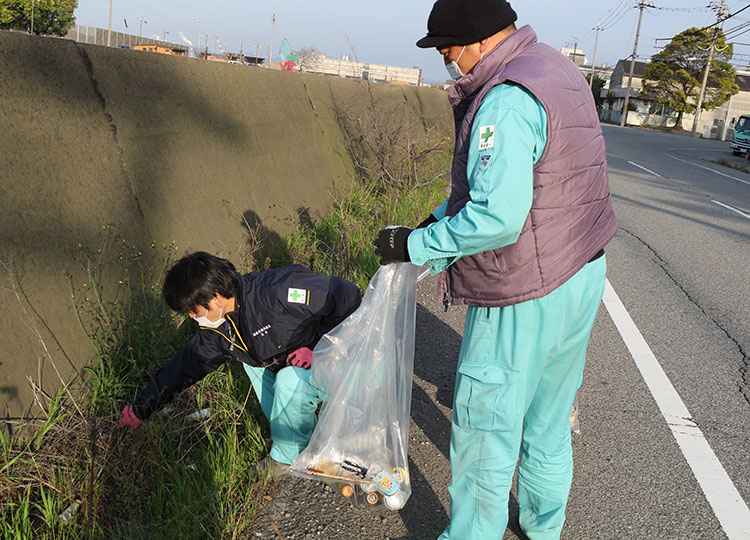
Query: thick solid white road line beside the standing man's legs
[[604, 280, 750, 540]]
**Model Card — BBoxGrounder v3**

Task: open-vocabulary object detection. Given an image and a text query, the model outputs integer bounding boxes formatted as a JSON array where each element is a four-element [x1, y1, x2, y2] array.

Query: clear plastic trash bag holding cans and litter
[[291, 263, 419, 510]]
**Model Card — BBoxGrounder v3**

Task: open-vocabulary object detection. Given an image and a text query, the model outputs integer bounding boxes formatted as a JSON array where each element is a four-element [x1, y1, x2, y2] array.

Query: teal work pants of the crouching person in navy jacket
[[243, 364, 323, 463]]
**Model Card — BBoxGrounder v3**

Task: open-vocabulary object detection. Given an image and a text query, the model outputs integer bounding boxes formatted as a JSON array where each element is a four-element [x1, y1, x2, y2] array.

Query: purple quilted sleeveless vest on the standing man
[[440, 26, 617, 307]]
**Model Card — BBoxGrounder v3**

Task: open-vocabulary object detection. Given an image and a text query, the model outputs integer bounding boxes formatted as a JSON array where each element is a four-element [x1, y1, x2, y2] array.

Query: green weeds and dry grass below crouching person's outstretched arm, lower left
[[0, 236, 268, 540]]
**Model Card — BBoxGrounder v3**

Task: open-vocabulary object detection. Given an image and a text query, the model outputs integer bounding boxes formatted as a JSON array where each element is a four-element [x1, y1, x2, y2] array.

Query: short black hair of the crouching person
[[162, 251, 239, 313]]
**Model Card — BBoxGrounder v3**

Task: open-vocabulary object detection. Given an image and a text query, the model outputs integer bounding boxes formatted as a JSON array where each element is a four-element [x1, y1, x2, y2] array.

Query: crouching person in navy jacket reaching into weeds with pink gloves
[[120, 252, 361, 477]]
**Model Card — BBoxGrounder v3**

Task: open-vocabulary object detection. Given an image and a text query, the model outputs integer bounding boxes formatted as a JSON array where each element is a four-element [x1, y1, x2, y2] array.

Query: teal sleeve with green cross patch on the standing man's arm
[[408, 84, 547, 274]]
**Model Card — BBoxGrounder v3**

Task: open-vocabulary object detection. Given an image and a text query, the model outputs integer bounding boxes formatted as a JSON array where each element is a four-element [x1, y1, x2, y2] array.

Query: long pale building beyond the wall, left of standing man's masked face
[[299, 54, 422, 86]]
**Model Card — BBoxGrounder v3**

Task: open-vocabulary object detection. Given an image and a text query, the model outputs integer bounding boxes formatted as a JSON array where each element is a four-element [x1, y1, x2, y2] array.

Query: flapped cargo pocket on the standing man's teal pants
[[453, 363, 519, 431]]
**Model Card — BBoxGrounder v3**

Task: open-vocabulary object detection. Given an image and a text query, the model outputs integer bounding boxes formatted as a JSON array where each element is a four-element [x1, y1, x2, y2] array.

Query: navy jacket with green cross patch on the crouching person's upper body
[[133, 265, 361, 420]]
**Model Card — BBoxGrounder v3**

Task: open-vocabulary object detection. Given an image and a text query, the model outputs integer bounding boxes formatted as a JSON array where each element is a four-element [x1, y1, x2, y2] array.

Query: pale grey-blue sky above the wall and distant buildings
[[76, 0, 750, 82]]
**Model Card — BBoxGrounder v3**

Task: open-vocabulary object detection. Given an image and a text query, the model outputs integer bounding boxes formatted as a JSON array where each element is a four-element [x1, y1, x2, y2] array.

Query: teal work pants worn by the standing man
[[440, 257, 606, 540]]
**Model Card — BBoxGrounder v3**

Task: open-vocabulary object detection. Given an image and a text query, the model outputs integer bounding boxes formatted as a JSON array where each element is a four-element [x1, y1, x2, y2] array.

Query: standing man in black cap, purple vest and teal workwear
[[375, 0, 617, 540]]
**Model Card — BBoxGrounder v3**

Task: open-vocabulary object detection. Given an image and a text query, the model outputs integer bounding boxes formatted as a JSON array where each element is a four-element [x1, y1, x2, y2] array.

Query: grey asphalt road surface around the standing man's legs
[[251, 126, 750, 540]]
